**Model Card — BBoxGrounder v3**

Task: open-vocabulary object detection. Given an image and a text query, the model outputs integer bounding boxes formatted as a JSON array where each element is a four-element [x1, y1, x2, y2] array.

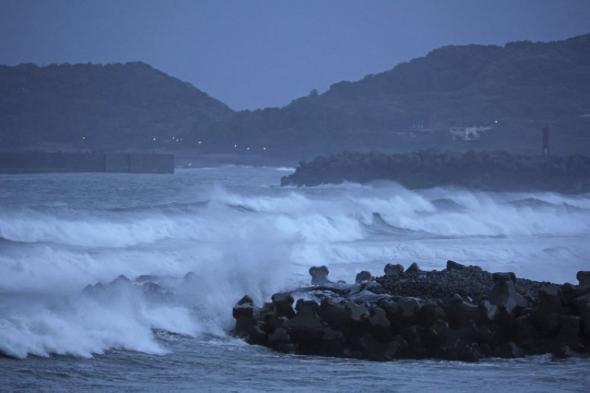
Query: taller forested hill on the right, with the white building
[[217, 34, 590, 152]]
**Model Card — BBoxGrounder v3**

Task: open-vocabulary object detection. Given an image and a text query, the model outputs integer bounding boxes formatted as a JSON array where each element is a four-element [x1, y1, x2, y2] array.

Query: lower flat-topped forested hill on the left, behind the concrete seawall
[[0, 62, 232, 150]]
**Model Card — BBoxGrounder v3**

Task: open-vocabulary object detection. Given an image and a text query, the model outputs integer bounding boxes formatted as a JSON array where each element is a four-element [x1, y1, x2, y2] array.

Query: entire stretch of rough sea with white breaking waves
[[0, 165, 590, 392]]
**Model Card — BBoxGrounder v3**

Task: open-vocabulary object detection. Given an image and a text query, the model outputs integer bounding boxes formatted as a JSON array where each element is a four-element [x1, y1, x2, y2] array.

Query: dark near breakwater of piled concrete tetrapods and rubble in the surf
[[233, 261, 590, 361]]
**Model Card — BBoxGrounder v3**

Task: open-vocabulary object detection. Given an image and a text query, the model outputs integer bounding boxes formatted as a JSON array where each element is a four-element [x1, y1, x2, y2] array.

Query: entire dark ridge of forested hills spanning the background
[[0, 34, 590, 156]]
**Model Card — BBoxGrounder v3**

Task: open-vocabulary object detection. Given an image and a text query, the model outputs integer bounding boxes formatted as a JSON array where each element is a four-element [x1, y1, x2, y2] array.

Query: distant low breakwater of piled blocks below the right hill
[[281, 151, 590, 193]]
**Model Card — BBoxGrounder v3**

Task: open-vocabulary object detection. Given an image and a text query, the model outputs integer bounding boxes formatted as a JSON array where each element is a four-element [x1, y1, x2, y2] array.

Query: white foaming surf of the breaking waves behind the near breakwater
[[0, 173, 590, 357]]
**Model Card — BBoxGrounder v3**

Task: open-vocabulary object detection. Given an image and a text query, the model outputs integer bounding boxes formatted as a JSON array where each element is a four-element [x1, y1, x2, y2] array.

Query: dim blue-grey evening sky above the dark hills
[[0, 0, 590, 109]]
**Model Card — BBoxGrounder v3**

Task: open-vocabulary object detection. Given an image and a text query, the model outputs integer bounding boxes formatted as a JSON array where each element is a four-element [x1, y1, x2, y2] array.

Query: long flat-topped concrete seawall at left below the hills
[[0, 152, 174, 173]]
